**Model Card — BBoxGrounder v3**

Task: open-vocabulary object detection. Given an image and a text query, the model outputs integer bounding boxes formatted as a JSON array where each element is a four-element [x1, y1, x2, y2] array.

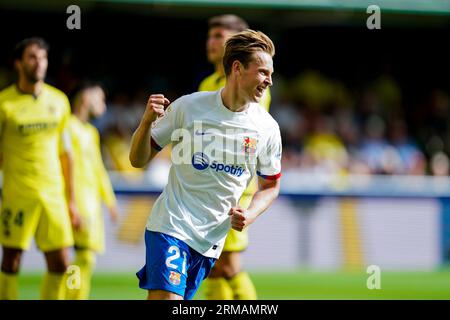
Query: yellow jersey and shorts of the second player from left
[[68, 115, 116, 251]]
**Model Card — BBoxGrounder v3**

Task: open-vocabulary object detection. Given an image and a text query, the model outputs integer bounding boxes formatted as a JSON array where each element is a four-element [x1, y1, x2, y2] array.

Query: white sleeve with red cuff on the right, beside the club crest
[[256, 127, 282, 180]]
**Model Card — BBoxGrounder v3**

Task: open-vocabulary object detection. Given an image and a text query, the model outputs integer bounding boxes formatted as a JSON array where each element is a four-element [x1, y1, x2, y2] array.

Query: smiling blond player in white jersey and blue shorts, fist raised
[[130, 30, 282, 299]]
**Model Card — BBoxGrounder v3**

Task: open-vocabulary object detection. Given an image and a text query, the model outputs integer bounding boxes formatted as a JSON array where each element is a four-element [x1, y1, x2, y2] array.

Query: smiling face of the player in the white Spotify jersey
[[239, 51, 273, 102]]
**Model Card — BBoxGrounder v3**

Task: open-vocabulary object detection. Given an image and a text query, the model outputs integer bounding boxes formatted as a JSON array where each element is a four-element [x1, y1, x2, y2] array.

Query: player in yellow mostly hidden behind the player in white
[[199, 14, 270, 300]]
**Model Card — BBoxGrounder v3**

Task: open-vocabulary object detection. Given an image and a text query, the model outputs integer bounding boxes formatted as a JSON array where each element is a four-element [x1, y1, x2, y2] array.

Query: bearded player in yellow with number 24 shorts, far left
[[0, 38, 79, 299]]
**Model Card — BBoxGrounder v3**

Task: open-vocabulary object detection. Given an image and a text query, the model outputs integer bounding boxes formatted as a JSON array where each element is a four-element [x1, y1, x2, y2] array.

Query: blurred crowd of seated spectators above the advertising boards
[[0, 65, 450, 176]]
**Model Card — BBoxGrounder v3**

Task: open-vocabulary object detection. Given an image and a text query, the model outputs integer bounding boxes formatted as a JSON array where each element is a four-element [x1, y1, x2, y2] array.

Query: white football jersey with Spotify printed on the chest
[[147, 90, 281, 258]]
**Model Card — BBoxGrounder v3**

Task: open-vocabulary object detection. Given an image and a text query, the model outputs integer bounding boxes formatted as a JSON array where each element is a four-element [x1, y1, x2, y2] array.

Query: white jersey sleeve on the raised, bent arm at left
[[150, 99, 182, 151]]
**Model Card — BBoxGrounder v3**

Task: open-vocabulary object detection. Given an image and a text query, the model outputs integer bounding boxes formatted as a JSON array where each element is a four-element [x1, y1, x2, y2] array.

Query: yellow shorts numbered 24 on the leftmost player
[[0, 194, 73, 252]]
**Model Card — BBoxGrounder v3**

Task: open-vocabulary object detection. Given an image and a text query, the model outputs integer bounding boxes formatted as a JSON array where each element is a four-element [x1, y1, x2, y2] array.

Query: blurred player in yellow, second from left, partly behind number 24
[[67, 83, 117, 300]]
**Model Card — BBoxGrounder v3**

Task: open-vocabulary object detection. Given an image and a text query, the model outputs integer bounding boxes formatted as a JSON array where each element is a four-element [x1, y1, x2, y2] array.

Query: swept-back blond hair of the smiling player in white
[[223, 29, 275, 76]]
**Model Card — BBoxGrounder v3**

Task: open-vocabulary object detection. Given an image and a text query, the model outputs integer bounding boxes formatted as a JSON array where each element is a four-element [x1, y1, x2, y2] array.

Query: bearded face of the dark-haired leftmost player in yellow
[[18, 44, 48, 83]]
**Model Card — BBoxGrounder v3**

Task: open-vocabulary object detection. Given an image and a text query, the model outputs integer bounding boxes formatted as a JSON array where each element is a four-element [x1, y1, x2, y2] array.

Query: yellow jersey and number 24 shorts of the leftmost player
[[0, 84, 73, 252]]
